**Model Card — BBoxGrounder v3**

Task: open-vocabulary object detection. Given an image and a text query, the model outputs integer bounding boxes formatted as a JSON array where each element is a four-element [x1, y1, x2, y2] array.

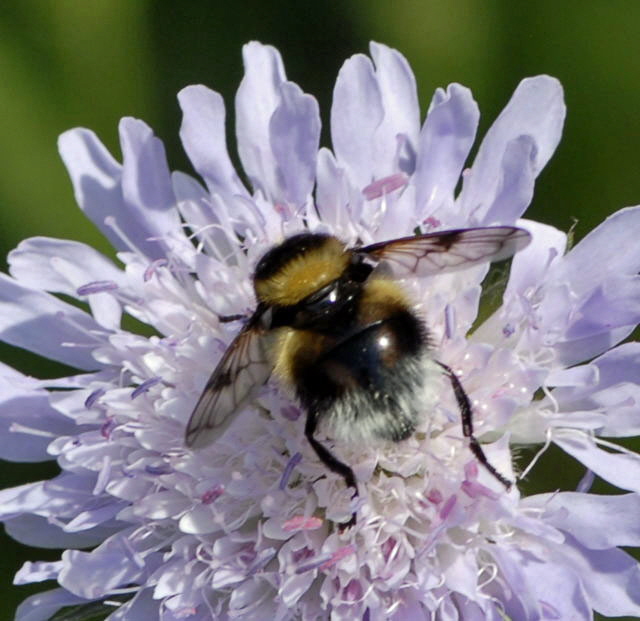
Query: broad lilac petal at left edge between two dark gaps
[[0, 364, 77, 462]]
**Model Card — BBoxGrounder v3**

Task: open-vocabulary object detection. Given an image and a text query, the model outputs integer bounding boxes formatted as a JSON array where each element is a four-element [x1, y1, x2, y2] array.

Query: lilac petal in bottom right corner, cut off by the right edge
[[561, 535, 640, 617]]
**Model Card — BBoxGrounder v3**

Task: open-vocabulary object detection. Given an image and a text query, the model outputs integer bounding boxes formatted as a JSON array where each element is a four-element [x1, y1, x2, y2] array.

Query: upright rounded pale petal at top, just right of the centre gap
[[331, 54, 384, 189]]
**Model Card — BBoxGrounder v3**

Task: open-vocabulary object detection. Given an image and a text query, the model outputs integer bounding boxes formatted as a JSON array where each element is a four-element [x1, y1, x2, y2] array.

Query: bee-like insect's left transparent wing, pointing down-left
[[185, 312, 273, 448]]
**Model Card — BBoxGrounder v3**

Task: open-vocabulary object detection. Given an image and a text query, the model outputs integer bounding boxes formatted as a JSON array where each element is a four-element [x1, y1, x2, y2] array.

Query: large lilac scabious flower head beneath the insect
[[0, 43, 640, 621]]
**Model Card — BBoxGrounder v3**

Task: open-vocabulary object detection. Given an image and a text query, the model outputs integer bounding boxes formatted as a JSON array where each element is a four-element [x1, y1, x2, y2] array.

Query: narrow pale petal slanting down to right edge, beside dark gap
[[553, 430, 640, 493]]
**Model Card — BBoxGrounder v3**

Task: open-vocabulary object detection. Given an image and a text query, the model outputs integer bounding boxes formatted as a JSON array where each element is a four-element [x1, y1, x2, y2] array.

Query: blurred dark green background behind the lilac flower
[[0, 0, 640, 620]]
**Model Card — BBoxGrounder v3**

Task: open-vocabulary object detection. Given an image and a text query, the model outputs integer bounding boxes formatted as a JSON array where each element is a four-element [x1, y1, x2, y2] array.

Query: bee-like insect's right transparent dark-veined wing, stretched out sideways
[[355, 226, 531, 278]]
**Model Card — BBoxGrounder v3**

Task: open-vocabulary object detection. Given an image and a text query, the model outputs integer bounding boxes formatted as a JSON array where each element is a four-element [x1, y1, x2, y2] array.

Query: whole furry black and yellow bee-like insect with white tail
[[185, 226, 530, 527]]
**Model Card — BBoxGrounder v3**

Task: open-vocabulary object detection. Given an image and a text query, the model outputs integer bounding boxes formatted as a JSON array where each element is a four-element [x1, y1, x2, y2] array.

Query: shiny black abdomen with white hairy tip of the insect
[[296, 309, 427, 442]]
